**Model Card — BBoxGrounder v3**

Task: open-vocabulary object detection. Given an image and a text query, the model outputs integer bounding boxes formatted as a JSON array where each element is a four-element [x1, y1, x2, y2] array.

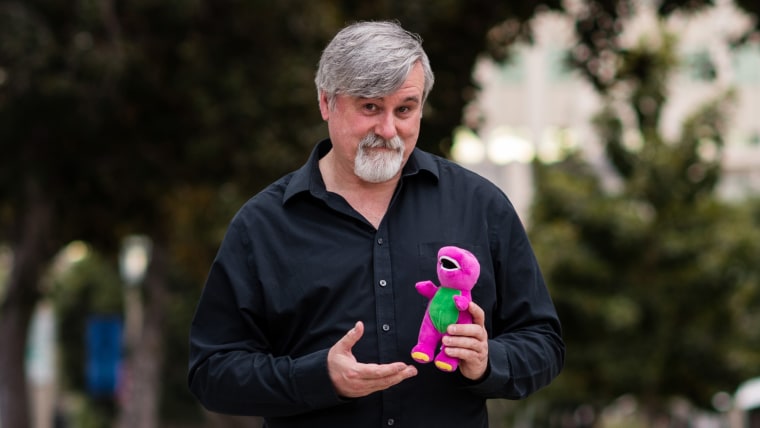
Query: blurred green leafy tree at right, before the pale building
[[531, 17, 760, 420]]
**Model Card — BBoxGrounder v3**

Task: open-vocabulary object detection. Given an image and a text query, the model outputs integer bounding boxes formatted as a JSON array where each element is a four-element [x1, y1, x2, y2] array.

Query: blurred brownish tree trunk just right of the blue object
[[117, 242, 169, 428]]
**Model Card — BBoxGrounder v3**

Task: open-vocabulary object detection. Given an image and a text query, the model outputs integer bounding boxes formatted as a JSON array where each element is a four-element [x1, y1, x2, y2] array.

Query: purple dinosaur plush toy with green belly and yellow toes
[[412, 246, 480, 372]]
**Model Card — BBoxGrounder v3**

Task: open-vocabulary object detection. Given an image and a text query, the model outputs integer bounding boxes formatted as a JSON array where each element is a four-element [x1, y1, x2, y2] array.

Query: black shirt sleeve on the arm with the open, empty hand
[[188, 220, 343, 417]]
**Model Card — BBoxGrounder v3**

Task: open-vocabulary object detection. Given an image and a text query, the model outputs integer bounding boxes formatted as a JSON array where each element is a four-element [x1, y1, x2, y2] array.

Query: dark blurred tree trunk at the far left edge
[[0, 184, 57, 428]]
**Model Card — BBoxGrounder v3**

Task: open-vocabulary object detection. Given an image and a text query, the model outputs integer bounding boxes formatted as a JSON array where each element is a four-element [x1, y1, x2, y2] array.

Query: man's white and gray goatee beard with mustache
[[354, 133, 404, 183]]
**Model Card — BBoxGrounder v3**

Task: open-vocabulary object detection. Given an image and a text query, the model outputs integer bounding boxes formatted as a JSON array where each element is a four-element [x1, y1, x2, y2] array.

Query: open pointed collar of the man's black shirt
[[282, 138, 439, 204]]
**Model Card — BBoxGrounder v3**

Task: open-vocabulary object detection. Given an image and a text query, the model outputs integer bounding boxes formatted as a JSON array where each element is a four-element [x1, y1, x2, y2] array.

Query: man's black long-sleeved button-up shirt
[[189, 140, 564, 428]]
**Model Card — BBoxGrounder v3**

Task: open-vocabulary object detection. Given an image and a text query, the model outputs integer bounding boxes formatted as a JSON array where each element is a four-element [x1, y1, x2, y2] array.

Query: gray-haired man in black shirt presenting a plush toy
[[189, 22, 564, 428]]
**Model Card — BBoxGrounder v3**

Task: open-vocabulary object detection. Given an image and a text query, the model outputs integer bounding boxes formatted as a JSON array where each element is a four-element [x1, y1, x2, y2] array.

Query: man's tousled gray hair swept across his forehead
[[314, 21, 435, 108]]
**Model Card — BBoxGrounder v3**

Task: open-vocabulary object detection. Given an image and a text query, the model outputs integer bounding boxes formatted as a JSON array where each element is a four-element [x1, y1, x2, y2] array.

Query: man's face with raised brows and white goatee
[[319, 63, 425, 183]]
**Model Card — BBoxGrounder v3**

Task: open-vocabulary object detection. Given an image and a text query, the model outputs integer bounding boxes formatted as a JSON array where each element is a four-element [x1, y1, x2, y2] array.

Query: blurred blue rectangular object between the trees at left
[[85, 315, 123, 397]]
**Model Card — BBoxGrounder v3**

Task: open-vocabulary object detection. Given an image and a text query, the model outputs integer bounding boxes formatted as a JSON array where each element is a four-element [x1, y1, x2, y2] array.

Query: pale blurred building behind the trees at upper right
[[452, 0, 760, 221]]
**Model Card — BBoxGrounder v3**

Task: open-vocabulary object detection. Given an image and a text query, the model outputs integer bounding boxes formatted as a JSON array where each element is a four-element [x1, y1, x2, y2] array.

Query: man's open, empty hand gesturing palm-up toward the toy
[[327, 321, 417, 398]]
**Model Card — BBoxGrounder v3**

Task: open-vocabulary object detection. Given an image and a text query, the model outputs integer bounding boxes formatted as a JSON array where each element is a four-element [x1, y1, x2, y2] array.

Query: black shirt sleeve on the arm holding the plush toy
[[468, 204, 565, 399]]
